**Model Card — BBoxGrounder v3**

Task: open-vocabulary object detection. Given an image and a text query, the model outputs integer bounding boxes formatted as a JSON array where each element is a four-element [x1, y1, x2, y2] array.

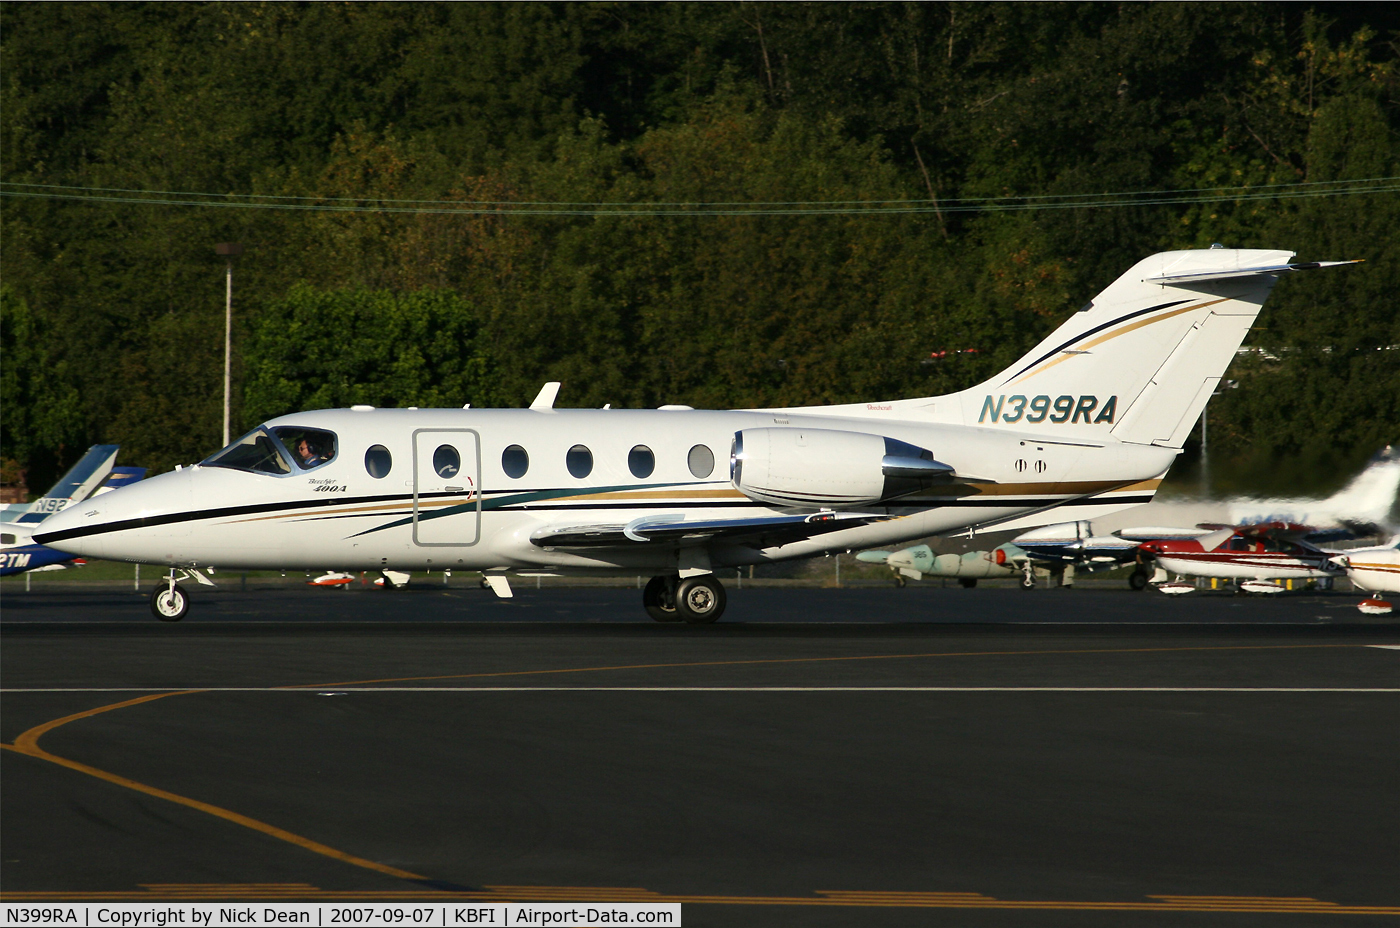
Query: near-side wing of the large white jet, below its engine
[[529, 512, 889, 547]]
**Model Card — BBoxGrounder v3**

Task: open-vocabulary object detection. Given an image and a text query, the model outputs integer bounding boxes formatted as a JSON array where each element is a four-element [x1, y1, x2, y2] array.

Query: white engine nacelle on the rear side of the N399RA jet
[[729, 428, 953, 508]]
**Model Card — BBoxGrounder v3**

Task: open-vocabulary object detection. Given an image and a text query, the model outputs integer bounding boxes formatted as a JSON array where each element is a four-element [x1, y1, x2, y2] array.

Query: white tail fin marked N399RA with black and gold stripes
[[940, 248, 1351, 448]]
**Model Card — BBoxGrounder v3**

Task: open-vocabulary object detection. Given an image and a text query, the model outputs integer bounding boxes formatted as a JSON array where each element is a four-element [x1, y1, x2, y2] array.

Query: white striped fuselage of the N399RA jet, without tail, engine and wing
[[45, 409, 1177, 574]]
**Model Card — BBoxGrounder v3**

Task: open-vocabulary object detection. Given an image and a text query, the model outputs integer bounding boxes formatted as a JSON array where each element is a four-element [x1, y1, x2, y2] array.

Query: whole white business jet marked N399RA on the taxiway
[[35, 246, 1351, 623]]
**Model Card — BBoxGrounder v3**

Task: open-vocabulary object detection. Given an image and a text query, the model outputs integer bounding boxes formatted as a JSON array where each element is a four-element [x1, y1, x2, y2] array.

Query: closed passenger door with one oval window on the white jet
[[413, 428, 482, 547]]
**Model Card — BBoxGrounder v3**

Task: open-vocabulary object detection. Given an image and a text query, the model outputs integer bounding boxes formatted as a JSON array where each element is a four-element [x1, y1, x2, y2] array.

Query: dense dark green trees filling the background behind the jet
[[0, 3, 1400, 486]]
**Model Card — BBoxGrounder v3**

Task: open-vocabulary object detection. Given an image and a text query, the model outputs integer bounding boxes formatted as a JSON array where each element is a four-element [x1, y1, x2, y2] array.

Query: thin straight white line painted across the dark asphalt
[[0, 686, 1400, 696]]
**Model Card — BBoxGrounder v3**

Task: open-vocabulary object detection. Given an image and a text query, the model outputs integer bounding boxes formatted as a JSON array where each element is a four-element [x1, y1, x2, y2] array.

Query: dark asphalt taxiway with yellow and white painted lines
[[0, 588, 1400, 925]]
